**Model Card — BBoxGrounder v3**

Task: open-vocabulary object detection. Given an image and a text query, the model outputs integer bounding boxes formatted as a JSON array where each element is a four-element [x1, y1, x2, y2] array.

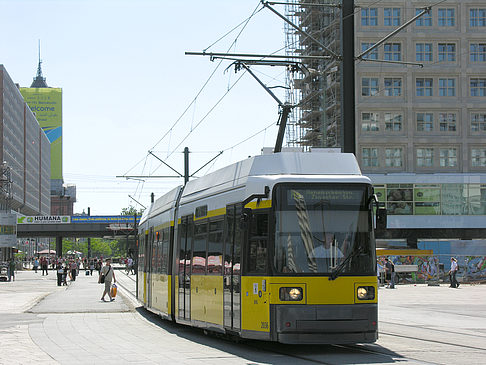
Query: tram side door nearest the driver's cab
[[223, 204, 244, 331]]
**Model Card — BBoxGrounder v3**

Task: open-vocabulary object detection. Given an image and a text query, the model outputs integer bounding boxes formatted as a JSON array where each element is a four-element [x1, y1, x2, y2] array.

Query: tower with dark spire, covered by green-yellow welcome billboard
[[20, 56, 76, 215]]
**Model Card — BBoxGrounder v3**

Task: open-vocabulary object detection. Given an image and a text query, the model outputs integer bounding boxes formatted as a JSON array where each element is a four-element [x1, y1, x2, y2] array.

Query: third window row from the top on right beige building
[[361, 77, 486, 97]]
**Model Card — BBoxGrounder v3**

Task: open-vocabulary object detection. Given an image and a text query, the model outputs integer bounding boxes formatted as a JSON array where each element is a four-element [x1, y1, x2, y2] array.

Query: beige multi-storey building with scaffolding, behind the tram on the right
[[286, 0, 486, 246]]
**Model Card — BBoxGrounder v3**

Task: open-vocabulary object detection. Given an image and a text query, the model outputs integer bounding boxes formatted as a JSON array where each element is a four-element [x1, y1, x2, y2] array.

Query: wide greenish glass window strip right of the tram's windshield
[[374, 184, 486, 215]]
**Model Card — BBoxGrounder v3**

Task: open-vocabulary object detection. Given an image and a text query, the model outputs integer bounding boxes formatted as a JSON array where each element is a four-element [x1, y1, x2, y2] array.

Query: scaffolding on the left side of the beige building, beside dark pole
[[285, 0, 341, 150]]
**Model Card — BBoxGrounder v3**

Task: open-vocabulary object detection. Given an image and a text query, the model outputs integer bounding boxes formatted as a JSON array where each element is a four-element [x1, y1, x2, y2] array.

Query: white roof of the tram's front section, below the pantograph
[[182, 152, 362, 200]]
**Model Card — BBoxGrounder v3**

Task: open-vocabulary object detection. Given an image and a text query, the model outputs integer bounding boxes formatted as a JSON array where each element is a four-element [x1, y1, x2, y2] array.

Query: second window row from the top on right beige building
[[361, 41, 486, 63]]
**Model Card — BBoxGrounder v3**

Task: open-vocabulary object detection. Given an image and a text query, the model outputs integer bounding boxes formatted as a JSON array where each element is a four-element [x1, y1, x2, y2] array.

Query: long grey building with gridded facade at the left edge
[[0, 65, 51, 260]]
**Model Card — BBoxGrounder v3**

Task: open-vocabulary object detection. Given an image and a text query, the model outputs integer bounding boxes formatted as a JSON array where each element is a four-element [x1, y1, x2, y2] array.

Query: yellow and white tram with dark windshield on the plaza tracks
[[137, 152, 382, 344]]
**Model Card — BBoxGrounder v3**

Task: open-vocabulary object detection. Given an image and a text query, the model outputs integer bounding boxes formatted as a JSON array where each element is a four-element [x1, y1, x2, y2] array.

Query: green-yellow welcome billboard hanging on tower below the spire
[[20, 87, 62, 180]]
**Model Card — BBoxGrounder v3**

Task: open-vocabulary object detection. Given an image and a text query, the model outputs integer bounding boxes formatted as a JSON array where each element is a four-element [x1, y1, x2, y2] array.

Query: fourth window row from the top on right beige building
[[361, 110, 486, 135]]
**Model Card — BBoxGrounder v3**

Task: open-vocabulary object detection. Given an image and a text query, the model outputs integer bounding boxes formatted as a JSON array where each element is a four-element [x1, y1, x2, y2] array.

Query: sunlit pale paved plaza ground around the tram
[[0, 270, 486, 365]]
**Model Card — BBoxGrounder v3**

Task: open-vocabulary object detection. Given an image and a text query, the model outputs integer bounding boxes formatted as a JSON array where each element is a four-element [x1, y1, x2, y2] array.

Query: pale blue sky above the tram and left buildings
[[0, 0, 285, 215]]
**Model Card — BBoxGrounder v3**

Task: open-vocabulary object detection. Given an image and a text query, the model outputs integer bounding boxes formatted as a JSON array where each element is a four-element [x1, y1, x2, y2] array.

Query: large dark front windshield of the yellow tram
[[274, 184, 376, 276]]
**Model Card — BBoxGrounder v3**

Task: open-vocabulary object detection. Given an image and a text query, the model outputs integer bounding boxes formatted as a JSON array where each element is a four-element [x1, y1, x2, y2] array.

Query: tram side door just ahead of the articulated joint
[[177, 215, 192, 320]]
